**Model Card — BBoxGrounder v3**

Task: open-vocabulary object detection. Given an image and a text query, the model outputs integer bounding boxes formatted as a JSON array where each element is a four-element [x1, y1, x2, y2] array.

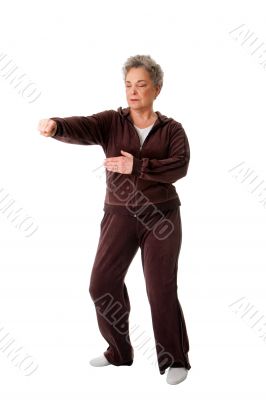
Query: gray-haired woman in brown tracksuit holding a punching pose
[[38, 55, 191, 384]]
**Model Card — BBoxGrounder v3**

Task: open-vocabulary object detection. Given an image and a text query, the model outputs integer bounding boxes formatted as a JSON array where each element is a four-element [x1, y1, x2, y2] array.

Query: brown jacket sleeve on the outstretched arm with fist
[[50, 110, 115, 148]]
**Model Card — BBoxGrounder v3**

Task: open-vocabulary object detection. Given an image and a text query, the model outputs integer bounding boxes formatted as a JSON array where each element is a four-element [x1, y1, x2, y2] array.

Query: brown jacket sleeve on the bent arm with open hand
[[131, 123, 190, 183]]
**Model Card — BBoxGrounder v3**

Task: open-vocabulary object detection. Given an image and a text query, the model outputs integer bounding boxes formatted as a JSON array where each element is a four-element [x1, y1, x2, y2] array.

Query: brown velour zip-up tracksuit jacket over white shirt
[[51, 107, 190, 216]]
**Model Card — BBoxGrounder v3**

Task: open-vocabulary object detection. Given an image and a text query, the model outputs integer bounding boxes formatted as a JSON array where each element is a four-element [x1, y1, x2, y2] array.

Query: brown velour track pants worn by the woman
[[89, 207, 191, 374]]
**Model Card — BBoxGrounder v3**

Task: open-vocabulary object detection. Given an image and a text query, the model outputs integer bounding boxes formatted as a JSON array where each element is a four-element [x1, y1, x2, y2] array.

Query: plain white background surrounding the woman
[[0, 0, 266, 400]]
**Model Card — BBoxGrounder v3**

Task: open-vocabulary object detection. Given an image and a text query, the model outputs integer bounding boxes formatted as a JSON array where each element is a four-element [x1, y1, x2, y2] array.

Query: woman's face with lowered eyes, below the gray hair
[[125, 67, 159, 110]]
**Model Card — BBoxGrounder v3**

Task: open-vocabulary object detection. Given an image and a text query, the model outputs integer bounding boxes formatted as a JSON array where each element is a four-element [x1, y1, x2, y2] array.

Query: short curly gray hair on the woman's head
[[122, 54, 164, 88]]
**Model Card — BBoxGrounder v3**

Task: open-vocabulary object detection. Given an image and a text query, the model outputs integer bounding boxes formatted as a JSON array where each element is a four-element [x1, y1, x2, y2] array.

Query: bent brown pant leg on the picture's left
[[89, 212, 139, 365]]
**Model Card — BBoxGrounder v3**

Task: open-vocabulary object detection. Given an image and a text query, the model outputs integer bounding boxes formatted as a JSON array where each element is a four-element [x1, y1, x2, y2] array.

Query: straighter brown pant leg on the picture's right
[[138, 208, 191, 374]]
